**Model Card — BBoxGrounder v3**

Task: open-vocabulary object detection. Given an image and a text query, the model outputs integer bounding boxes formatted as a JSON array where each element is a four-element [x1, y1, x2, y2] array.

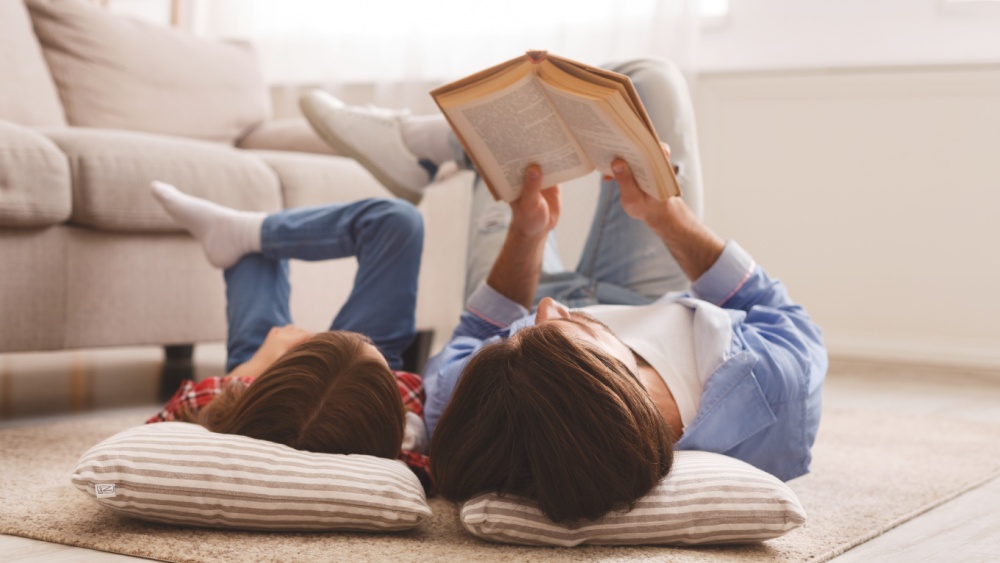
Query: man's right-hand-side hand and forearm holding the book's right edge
[[611, 143, 726, 281]]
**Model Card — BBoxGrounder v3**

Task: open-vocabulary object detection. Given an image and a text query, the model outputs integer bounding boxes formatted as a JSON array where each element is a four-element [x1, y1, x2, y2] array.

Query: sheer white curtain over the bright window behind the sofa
[[191, 0, 699, 85]]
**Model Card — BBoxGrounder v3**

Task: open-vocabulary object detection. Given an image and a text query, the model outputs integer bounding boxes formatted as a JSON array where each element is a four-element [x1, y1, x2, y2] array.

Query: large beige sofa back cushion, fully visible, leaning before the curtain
[[25, 0, 270, 143]]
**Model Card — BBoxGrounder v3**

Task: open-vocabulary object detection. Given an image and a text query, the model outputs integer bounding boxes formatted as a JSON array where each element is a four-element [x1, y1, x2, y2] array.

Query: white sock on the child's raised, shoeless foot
[[152, 182, 267, 268]]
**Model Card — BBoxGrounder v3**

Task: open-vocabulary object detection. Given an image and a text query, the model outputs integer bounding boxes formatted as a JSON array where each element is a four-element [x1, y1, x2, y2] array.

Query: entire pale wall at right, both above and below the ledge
[[694, 0, 1000, 368]]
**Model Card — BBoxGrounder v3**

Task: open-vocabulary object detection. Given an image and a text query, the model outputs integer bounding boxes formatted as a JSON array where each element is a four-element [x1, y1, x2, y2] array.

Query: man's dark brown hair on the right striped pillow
[[430, 324, 673, 522]]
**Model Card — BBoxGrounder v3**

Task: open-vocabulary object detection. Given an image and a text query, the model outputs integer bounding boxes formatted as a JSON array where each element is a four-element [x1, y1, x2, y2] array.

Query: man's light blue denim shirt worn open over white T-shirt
[[424, 241, 827, 481]]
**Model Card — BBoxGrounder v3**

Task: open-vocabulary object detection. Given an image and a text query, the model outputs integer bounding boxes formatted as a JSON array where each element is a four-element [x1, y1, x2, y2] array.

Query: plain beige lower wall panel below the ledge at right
[[696, 65, 1000, 367]]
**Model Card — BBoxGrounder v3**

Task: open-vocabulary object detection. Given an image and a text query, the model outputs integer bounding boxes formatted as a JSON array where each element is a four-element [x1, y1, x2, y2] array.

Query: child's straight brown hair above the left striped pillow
[[194, 331, 405, 459]]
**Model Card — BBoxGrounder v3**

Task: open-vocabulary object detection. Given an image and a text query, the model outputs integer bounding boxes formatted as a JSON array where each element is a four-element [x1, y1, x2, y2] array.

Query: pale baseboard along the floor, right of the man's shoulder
[[823, 331, 1000, 370]]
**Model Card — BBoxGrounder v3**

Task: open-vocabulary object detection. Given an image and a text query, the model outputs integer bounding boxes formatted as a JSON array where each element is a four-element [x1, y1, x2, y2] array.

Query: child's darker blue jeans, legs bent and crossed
[[225, 199, 424, 371]]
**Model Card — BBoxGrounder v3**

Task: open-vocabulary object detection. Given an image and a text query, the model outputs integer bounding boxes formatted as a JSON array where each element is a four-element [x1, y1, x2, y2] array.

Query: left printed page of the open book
[[442, 75, 593, 201]]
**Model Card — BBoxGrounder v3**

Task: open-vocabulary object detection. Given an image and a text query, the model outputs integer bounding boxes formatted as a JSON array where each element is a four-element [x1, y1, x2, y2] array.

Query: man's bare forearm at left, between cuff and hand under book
[[486, 229, 548, 309]]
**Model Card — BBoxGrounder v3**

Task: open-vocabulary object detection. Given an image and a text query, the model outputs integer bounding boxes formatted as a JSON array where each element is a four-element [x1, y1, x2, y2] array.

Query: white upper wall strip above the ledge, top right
[[697, 0, 1000, 72]]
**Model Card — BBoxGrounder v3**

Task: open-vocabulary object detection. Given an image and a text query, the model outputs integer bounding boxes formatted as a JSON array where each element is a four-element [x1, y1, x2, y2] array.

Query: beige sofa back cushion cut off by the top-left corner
[[0, 0, 66, 125]]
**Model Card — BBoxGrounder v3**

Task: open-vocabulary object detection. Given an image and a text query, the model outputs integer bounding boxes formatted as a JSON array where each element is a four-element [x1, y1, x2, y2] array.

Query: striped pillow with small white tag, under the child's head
[[71, 422, 431, 531]]
